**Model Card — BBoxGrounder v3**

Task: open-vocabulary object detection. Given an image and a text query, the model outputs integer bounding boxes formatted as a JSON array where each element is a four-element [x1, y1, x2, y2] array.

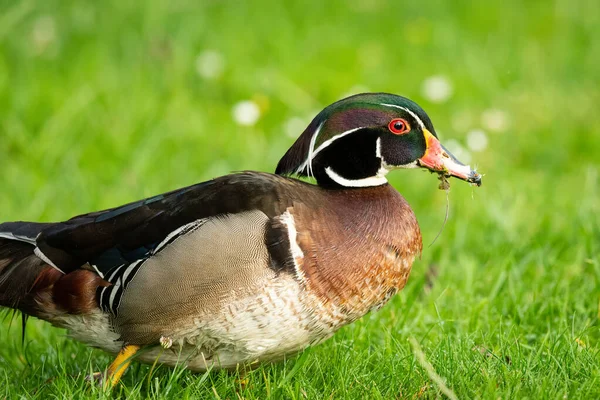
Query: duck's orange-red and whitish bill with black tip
[[418, 129, 481, 186]]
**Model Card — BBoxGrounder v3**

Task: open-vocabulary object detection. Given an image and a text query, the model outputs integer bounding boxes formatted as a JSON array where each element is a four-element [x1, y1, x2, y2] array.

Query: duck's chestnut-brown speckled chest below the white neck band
[[284, 185, 422, 325]]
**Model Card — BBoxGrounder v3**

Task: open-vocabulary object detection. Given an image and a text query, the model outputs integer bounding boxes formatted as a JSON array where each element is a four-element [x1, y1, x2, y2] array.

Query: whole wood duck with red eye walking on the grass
[[0, 93, 481, 384]]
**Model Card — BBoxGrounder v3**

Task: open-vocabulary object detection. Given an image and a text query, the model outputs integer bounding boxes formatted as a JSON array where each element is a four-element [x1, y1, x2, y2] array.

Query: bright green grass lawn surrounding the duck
[[0, 0, 600, 399]]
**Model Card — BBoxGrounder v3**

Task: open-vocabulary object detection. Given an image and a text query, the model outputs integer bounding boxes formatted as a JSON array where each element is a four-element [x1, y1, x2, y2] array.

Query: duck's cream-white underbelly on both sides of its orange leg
[[55, 274, 337, 371]]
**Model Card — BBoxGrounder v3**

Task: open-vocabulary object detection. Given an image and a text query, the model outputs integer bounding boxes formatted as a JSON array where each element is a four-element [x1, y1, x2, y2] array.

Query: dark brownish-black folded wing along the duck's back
[[5, 172, 286, 276]]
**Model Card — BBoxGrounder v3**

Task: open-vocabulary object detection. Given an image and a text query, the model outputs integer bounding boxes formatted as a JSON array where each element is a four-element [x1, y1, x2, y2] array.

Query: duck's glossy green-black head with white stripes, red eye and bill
[[276, 93, 481, 187]]
